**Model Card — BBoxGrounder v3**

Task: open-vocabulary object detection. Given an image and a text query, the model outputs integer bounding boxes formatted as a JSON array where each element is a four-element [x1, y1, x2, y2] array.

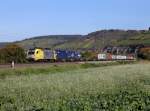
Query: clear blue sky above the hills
[[0, 0, 150, 42]]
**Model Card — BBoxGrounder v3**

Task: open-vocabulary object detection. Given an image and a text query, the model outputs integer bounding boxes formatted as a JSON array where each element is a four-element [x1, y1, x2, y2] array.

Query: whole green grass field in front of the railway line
[[0, 63, 150, 111]]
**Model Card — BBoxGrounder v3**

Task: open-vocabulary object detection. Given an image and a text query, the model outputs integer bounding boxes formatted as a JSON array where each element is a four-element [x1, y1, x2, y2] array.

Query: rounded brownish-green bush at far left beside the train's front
[[0, 44, 26, 63]]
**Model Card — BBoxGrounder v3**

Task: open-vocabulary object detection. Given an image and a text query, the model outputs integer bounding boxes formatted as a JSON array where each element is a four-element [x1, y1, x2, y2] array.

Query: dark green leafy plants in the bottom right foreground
[[50, 91, 150, 111]]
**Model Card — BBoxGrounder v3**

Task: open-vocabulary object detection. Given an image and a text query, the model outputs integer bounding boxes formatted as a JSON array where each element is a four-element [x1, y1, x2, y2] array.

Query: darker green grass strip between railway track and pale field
[[0, 61, 136, 79]]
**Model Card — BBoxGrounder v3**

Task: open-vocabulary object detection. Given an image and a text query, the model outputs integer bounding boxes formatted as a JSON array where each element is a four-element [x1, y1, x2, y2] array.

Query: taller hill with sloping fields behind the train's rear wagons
[[56, 30, 142, 49]]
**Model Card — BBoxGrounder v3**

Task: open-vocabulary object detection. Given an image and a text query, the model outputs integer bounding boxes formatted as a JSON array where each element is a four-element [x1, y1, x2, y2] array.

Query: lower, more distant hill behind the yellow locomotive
[[15, 35, 82, 49]]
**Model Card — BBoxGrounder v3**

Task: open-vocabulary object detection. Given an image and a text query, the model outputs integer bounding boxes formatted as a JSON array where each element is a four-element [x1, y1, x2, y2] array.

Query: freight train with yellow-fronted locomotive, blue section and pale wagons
[[27, 48, 136, 62]]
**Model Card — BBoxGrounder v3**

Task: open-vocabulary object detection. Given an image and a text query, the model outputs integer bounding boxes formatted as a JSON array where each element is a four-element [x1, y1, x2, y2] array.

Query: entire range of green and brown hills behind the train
[[0, 30, 150, 49]]
